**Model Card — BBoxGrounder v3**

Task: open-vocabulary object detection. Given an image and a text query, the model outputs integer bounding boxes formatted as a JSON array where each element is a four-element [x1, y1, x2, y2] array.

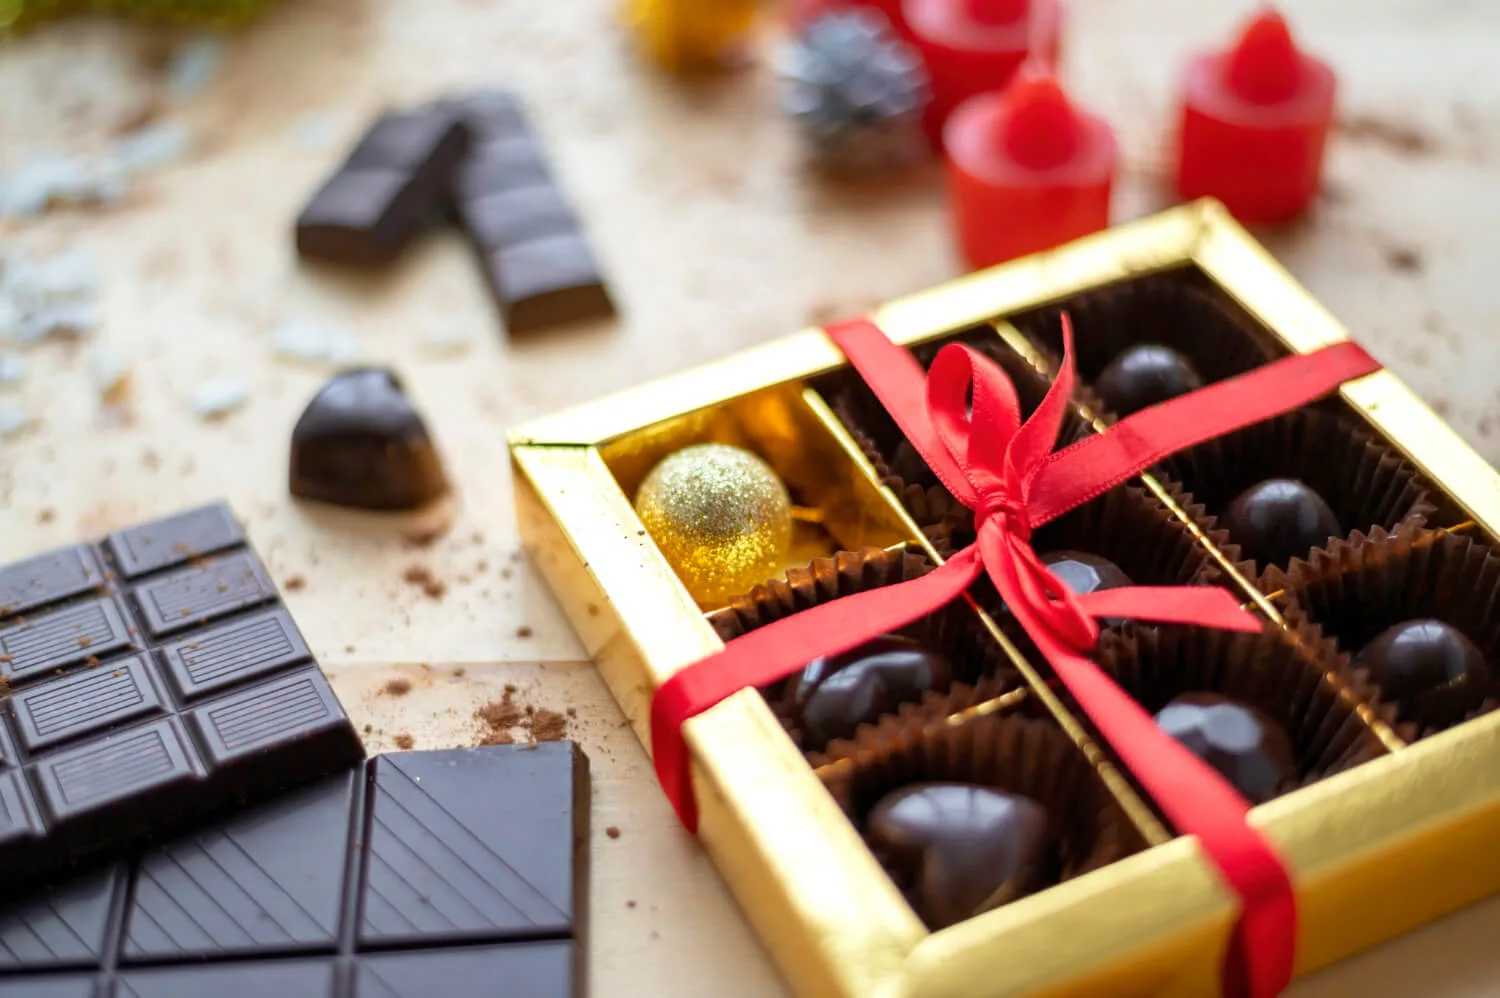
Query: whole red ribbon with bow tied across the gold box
[[651, 315, 1380, 998]]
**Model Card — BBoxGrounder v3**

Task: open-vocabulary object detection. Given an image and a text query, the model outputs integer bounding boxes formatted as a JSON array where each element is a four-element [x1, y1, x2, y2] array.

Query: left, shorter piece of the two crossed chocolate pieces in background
[[297, 107, 468, 266]]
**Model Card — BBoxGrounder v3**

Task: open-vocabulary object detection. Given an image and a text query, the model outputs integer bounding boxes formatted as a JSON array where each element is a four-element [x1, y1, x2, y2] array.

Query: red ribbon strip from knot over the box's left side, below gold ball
[[651, 548, 981, 833]]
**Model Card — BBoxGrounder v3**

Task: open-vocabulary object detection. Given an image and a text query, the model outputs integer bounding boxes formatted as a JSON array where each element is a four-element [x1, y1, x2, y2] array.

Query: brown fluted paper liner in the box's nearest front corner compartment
[[819, 714, 1143, 924]]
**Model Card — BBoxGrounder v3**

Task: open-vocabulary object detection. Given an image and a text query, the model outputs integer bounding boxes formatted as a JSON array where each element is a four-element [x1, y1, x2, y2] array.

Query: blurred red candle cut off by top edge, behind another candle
[[902, 0, 1062, 144]]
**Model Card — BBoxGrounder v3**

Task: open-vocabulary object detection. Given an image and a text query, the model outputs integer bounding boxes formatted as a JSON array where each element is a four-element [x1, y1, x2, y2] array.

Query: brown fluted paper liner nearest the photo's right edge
[[1260, 524, 1500, 741]]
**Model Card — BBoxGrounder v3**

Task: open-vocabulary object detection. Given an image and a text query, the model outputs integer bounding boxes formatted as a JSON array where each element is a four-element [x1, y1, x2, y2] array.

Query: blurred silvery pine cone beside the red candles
[[777, 8, 932, 171]]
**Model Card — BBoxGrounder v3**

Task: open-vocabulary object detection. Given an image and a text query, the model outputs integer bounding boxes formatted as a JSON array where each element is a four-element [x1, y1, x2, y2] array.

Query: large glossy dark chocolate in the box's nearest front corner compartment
[[866, 783, 1049, 929]]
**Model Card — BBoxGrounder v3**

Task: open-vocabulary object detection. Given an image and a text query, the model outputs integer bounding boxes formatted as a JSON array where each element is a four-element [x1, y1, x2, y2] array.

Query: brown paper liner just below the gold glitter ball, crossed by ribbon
[[710, 548, 1025, 750]]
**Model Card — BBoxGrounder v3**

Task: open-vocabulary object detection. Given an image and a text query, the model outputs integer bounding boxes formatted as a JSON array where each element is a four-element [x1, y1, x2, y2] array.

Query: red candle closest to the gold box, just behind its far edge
[[944, 65, 1116, 269]]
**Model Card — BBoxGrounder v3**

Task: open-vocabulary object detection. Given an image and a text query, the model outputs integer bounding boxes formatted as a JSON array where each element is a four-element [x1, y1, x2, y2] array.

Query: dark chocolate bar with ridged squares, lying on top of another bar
[[0, 503, 365, 888]]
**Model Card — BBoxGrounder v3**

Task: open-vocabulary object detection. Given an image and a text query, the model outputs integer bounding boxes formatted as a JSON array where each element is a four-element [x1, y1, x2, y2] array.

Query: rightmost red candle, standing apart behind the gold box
[[1178, 6, 1335, 222]]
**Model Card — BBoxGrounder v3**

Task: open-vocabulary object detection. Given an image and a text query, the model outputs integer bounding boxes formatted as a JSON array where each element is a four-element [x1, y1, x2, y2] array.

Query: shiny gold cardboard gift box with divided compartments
[[510, 201, 1500, 998]]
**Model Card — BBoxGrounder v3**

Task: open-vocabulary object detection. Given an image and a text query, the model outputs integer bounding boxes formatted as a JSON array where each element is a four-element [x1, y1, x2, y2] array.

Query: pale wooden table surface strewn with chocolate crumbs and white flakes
[[0, 0, 1500, 998]]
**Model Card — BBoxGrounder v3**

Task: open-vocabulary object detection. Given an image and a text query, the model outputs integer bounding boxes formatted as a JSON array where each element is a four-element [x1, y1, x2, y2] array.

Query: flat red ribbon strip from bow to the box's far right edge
[[1026, 342, 1380, 527]]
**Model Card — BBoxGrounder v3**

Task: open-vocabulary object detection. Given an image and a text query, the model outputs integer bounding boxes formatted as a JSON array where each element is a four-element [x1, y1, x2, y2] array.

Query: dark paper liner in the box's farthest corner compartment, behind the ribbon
[[1011, 273, 1286, 422]]
